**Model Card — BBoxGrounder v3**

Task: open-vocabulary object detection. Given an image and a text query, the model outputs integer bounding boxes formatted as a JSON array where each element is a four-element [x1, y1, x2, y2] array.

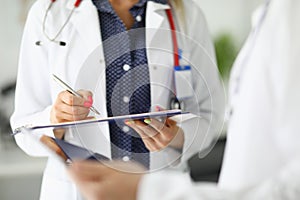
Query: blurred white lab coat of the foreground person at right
[[139, 0, 300, 200]]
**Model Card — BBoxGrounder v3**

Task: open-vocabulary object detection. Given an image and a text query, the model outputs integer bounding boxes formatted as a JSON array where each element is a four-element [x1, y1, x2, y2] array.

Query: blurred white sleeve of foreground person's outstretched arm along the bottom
[[137, 159, 300, 200]]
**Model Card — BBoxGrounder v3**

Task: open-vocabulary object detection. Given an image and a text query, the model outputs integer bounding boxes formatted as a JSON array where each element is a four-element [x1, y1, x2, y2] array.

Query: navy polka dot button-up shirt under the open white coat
[[93, 0, 167, 168]]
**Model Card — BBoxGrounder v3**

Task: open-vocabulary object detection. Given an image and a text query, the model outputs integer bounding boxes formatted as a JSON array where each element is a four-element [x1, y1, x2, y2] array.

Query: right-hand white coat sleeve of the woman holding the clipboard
[[166, 1, 226, 169]]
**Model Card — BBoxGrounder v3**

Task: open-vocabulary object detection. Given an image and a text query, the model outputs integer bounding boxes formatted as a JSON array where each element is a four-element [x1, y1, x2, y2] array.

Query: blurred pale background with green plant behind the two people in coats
[[0, 0, 263, 200]]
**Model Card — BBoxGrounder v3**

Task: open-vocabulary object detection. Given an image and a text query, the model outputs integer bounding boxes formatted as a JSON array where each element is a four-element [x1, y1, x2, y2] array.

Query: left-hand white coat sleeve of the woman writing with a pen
[[11, 0, 53, 156]]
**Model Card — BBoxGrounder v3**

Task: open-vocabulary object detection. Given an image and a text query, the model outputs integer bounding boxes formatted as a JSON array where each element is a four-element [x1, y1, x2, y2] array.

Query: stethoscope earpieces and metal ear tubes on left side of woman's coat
[[35, 0, 82, 46]]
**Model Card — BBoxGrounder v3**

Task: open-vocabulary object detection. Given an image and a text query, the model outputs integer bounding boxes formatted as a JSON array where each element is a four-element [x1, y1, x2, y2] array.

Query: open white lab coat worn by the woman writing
[[11, 0, 224, 199]]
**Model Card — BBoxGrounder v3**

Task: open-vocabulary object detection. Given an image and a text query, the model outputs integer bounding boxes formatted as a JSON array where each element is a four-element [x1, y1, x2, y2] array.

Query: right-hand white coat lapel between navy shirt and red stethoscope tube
[[146, 1, 173, 108]]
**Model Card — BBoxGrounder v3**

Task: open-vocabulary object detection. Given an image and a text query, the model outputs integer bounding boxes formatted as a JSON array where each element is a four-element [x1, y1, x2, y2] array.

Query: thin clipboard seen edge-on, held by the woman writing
[[12, 109, 191, 135]]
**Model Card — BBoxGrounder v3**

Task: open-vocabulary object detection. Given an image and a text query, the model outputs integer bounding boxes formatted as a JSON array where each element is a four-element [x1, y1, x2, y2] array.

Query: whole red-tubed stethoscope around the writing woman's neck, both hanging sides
[[35, 0, 184, 109]]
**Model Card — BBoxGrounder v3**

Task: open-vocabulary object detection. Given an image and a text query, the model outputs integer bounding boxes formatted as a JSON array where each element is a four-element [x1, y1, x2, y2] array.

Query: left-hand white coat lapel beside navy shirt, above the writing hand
[[67, 0, 109, 120]]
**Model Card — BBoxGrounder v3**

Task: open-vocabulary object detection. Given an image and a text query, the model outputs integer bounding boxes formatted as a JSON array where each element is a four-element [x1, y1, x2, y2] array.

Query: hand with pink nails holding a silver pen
[[51, 75, 100, 127]]
